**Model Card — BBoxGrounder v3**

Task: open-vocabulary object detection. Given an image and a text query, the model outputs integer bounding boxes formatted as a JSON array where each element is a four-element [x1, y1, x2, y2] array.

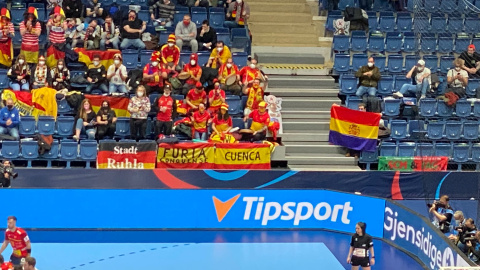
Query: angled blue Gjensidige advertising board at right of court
[[383, 201, 473, 270]]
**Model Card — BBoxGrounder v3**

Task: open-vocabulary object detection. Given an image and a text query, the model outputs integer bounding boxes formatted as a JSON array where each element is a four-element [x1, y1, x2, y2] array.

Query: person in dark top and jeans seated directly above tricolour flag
[[355, 57, 381, 98]]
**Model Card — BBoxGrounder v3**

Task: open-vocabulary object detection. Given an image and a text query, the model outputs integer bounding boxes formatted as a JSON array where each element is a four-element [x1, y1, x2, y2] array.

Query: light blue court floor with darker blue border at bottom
[[3, 231, 423, 270]]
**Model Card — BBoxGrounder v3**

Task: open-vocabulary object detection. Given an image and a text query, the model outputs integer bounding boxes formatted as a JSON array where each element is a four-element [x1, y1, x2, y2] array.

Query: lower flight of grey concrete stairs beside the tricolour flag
[[267, 75, 360, 171]]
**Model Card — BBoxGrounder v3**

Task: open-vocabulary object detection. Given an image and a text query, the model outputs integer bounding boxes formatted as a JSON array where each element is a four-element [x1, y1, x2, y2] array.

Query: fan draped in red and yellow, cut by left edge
[[0, 8, 15, 68]]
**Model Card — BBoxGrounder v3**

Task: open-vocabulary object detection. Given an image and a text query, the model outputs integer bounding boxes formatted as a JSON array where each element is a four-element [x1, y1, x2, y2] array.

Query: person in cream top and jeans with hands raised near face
[[107, 53, 128, 95]]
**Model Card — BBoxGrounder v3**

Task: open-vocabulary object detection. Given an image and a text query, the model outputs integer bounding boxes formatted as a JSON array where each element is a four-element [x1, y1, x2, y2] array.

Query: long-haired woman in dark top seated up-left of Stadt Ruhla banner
[[73, 99, 97, 141]]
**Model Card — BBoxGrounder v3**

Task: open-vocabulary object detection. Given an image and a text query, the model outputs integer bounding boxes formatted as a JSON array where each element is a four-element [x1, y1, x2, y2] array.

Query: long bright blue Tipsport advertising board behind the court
[[0, 189, 385, 237]]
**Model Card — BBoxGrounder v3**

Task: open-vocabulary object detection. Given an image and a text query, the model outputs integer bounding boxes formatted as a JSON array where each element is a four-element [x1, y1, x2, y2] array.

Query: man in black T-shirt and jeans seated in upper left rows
[[120, 10, 147, 51]]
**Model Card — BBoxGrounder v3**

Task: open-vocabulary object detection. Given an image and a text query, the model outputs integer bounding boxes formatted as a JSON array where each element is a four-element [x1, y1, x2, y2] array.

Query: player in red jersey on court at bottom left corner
[[0, 216, 32, 265]]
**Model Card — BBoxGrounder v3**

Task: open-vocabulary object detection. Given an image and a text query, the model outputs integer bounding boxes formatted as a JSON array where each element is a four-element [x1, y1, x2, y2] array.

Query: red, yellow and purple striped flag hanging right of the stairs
[[328, 105, 381, 152]]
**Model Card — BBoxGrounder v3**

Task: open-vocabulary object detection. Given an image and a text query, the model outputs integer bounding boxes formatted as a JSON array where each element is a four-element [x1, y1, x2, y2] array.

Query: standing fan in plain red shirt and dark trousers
[[153, 84, 177, 138]]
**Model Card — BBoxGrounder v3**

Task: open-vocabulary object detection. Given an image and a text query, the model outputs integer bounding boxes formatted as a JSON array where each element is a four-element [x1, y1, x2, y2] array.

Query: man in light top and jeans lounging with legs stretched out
[[393, 60, 432, 98]]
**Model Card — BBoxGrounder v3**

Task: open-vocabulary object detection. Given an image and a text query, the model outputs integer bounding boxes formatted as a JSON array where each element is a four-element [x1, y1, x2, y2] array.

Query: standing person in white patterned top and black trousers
[[128, 85, 151, 140]]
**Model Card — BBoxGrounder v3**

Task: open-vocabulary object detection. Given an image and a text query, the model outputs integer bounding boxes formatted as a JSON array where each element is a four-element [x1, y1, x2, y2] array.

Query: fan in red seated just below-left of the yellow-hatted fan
[[143, 51, 167, 94]]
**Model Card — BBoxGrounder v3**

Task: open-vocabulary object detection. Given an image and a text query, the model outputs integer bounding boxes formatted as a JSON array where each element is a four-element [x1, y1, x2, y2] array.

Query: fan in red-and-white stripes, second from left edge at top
[[20, 7, 42, 64]]
